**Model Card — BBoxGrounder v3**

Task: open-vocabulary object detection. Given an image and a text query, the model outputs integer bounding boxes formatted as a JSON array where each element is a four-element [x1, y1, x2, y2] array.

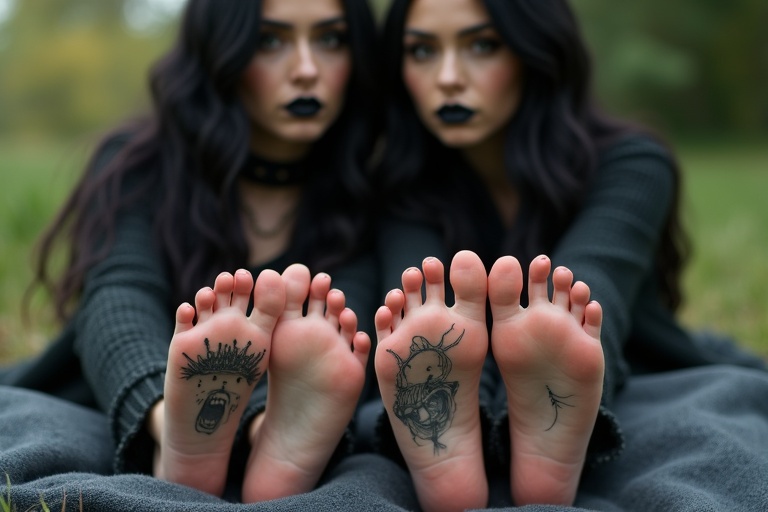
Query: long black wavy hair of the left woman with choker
[[33, 0, 378, 320]]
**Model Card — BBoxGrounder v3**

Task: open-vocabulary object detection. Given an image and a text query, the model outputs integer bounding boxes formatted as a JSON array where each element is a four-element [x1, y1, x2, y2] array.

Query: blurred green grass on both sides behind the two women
[[0, 136, 768, 362]]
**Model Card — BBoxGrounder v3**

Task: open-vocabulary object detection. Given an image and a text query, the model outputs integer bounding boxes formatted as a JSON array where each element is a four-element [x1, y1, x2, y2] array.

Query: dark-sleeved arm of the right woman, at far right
[[552, 138, 676, 405]]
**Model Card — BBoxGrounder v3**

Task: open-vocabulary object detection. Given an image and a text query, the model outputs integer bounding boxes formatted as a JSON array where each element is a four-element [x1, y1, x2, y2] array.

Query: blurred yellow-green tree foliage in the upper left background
[[0, 0, 175, 137]]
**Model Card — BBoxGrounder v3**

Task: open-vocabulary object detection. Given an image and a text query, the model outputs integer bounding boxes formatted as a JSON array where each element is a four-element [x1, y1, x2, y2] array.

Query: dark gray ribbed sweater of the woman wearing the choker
[[0, 135, 380, 473]]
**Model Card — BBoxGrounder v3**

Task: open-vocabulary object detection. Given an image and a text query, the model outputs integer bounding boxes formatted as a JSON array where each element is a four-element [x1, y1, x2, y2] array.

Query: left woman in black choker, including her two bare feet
[[11, 0, 377, 501]]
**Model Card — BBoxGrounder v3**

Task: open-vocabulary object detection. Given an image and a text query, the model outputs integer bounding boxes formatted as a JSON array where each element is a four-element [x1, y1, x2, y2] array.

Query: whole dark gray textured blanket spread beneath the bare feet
[[0, 366, 768, 512]]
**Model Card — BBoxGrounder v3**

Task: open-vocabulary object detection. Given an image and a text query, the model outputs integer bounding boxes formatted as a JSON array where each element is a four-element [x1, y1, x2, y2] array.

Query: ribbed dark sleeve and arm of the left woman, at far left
[[75, 142, 174, 471]]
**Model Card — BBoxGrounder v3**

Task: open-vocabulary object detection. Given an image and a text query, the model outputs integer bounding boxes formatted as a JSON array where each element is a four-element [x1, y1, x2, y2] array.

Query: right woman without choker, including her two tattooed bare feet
[[375, 0, 762, 510]]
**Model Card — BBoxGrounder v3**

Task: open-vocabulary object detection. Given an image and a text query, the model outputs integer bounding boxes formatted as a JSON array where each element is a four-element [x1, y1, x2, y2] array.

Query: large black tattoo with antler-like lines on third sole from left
[[387, 325, 464, 455]]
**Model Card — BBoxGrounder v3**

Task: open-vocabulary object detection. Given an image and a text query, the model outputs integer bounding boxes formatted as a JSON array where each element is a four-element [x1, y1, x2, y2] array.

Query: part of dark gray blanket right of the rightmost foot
[[577, 366, 768, 512]]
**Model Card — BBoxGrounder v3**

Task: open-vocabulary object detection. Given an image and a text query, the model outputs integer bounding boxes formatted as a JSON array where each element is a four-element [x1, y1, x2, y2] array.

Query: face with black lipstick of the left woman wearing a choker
[[241, 0, 352, 159]]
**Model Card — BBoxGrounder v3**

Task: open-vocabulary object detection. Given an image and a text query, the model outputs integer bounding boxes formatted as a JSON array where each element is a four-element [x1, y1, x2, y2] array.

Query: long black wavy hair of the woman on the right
[[376, 0, 688, 309]]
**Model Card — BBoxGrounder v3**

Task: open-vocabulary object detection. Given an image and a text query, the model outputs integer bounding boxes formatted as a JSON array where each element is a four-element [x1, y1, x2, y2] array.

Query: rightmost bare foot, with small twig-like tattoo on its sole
[[488, 256, 604, 505]]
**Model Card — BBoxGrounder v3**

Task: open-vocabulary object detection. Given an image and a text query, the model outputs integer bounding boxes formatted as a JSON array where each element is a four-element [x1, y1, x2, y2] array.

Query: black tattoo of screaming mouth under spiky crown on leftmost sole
[[181, 338, 267, 434]]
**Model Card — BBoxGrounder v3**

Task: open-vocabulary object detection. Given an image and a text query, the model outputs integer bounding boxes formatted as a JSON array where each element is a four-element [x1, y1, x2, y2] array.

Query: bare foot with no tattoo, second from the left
[[243, 265, 371, 503]]
